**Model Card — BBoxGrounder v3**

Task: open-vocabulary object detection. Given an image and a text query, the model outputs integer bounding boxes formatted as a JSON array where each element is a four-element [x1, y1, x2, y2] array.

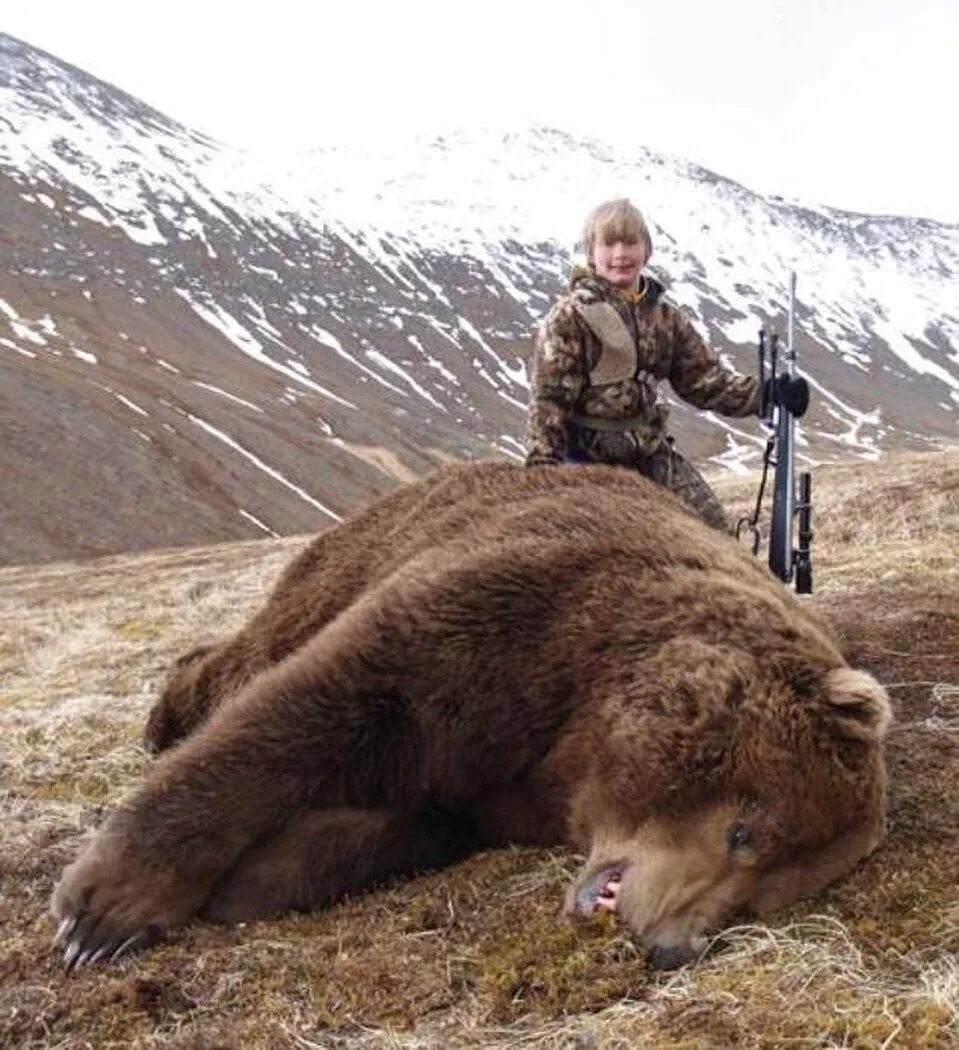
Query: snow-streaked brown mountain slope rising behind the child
[[0, 35, 959, 562]]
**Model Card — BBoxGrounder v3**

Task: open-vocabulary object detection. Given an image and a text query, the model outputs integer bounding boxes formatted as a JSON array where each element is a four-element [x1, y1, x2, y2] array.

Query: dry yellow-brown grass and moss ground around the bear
[[0, 453, 959, 1050]]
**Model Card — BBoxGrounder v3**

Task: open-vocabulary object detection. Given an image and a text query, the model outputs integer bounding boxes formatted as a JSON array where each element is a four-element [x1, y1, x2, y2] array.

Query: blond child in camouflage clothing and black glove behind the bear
[[526, 200, 809, 530]]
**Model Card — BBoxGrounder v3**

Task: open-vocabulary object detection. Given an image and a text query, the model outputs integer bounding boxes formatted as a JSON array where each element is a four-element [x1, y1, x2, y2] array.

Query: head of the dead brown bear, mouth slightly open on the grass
[[566, 637, 891, 968]]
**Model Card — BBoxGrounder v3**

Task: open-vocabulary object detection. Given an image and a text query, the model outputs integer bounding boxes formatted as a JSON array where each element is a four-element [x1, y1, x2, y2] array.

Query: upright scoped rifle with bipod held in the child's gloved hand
[[736, 273, 813, 594]]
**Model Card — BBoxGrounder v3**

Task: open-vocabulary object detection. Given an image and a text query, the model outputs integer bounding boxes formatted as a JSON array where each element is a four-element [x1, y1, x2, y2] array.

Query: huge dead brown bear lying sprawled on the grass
[[53, 463, 890, 966]]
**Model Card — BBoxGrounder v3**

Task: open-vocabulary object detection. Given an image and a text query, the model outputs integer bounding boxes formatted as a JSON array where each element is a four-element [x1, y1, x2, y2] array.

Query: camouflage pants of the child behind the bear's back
[[568, 429, 730, 532]]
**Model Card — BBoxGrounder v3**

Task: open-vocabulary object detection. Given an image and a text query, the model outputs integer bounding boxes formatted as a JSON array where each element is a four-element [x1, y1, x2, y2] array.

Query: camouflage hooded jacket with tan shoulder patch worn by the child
[[526, 269, 759, 466]]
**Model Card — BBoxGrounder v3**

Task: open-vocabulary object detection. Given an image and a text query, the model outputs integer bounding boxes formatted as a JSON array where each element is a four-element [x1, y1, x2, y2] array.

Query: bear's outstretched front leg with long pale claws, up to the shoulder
[[53, 550, 568, 960]]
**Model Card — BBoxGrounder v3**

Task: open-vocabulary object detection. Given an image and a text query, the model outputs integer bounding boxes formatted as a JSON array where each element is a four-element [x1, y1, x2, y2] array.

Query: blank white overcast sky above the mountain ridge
[[0, 0, 959, 222]]
